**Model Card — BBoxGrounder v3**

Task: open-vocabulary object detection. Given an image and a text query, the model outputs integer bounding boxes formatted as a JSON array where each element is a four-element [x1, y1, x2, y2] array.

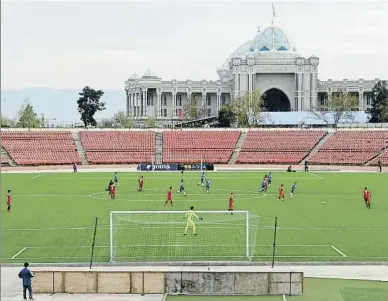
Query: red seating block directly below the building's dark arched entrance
[[236, 130, 327, 164]]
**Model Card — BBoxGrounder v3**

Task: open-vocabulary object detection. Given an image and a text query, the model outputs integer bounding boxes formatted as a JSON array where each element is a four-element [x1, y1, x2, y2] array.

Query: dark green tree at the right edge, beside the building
[[369, 81, 388, 122]]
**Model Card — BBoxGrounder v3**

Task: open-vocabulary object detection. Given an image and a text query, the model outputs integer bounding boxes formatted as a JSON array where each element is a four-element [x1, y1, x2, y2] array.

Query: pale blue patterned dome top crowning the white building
[[250, 27, 293, 52]]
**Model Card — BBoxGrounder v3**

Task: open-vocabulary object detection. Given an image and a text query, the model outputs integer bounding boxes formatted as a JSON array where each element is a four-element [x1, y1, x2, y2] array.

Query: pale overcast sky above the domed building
[[1, 0, 388, 91]]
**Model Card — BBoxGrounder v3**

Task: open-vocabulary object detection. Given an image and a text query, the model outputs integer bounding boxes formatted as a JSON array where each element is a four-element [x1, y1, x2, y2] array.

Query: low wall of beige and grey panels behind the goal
[[33, 270, 303, 295]]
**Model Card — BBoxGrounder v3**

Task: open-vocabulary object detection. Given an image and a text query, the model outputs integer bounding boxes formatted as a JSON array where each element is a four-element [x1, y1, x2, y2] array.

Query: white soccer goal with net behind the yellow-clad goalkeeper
[[110, 211, 260, 262]]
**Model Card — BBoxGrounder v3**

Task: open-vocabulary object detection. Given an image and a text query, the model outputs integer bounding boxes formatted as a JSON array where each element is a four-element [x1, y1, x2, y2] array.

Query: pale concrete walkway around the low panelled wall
[[1, 265, 388, 301]]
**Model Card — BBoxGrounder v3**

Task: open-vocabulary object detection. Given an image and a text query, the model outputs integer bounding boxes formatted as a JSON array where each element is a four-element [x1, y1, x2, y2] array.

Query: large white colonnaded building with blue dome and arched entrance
[[125, 26, 379, 126]]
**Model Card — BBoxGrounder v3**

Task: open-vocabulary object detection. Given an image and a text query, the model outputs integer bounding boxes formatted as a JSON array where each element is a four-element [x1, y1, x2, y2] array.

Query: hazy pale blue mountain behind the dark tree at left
[[1, 88, 125, 124]]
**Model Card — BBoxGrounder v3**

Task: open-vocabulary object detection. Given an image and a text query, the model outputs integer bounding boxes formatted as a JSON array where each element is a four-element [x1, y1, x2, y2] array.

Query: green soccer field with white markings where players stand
[[1, 172, 388, 263]]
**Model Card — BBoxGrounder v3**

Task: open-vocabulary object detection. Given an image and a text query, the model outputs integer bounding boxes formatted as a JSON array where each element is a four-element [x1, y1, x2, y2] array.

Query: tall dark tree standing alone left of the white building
[[77, 86, 105, 128]]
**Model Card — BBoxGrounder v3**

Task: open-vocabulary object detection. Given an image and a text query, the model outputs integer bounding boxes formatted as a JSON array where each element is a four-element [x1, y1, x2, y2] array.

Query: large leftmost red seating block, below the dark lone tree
[[1, 131, 80, 165]]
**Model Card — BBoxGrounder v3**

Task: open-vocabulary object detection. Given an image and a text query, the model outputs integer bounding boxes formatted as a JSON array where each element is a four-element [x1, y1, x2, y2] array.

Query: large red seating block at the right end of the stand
[[309, 130, 388, 164]]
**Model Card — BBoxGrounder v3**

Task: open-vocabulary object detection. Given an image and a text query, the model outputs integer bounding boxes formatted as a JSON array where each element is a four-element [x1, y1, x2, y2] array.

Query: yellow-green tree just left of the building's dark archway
[[231, 90, 265, 127]]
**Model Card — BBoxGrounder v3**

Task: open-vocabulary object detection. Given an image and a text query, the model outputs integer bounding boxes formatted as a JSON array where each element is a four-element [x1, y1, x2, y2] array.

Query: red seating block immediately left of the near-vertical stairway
[[80, 131, 155, 164]]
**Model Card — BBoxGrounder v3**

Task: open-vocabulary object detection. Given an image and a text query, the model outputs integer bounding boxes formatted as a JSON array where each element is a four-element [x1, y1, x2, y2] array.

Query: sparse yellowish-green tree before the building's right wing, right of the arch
[[310, 93, 358, 127]]
